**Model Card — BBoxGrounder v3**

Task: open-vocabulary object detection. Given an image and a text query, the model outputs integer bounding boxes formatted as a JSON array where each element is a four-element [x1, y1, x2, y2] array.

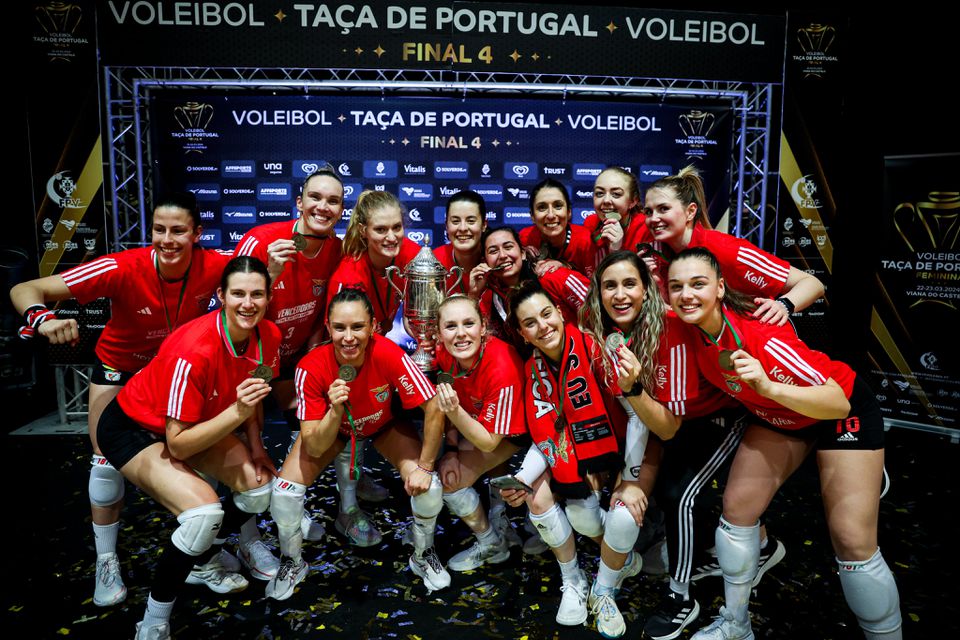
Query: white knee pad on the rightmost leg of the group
[[837, 549, 903, 637]]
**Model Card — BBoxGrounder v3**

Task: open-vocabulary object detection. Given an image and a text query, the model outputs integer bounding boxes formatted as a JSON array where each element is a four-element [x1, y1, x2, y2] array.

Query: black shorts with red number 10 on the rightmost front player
[[761, 376, 886, 451]]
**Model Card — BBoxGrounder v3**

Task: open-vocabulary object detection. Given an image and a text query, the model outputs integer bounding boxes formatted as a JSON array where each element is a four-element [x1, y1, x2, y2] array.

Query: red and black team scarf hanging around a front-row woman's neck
[[524, 324, 623, 498]]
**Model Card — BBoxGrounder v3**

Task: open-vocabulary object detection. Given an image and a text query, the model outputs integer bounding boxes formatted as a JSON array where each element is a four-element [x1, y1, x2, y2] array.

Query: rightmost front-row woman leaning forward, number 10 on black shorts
[[668, 247, 902, 639]]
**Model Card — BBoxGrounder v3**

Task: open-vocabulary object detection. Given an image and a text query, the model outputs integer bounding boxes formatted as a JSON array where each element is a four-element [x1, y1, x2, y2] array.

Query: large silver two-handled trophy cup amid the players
[[386, 247, 463, 373]]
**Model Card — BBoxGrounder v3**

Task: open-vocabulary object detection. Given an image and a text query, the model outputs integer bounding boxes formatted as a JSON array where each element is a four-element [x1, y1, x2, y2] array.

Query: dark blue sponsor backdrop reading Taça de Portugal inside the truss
[[150, 91, 732, 249]]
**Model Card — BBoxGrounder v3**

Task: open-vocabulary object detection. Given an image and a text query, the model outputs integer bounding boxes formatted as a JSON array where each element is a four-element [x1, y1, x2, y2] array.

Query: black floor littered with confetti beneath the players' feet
[[2, 420, 960, 640]]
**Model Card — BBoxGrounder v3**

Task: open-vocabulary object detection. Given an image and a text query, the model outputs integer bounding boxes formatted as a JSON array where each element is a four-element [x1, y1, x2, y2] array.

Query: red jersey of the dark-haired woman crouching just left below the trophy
[[294, 334, 436, 438]]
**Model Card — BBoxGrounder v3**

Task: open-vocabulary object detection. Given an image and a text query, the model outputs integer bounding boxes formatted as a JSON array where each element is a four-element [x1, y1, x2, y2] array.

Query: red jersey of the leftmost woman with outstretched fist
[[60, 247, 230, 372]]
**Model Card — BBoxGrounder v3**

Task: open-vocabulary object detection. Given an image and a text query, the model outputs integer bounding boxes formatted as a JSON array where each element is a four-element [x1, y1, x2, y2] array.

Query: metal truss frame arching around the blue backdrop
[[50, 67, 780, 423]]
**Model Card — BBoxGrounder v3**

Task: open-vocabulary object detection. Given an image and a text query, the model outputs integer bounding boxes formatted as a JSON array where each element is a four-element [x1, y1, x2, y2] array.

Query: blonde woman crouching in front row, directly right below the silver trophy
[[437, 294, 530, 571]]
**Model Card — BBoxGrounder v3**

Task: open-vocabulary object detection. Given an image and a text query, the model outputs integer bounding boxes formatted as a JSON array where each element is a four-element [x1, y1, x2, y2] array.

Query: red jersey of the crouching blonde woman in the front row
[[437, 336, 527, 436]]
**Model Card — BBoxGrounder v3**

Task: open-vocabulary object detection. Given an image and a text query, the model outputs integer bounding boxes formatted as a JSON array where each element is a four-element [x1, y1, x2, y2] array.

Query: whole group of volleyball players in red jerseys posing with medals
[[11, 162, 901, 640]]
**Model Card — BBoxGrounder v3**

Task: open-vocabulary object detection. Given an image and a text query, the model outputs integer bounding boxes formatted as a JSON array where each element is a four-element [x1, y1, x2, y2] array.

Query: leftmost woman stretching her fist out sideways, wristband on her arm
[[10, 193, 232, 607]]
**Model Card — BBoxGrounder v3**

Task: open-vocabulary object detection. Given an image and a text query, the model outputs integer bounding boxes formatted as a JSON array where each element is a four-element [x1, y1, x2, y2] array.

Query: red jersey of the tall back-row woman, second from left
[[234, 221, 343, 364]]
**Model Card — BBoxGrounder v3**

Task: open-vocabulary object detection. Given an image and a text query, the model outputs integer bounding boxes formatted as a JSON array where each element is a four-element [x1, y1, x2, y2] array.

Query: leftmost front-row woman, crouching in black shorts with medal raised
[[97, 257, 280, 638]]
